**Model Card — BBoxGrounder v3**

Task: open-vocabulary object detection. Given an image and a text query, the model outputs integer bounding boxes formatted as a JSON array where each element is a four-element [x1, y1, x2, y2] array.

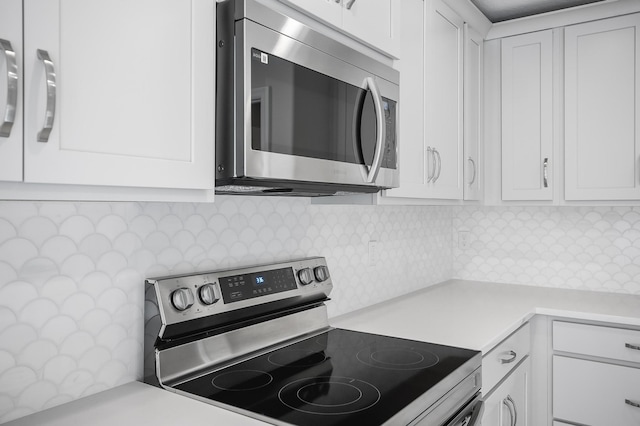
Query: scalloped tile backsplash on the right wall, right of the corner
[[453, 207, 640, 295]]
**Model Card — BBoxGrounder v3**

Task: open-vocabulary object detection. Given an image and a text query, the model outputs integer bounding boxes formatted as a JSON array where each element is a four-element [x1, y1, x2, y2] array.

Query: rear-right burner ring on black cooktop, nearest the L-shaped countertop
[[356, 347, 440, 370]]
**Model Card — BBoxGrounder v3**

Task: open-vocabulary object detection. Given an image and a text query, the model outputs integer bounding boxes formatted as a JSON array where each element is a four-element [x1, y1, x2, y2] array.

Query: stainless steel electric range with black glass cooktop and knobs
[[144, 257, 483, 426]]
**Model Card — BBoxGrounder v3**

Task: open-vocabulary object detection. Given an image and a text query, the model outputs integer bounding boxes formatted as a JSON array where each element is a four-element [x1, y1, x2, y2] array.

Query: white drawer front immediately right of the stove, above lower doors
[[482, 323, 531, 394]]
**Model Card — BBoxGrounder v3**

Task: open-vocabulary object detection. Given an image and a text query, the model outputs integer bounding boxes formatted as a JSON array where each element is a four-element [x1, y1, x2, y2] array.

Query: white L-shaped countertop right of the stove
[[330, 280, 640, 353]]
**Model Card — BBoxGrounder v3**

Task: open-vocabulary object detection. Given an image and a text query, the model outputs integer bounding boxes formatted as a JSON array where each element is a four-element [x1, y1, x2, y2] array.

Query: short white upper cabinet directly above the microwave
[[281, 0, 401, 57]]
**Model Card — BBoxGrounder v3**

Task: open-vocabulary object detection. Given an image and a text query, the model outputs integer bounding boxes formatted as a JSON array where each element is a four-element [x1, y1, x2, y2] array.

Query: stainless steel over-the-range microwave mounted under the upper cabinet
[[216, 0, 399, 196]]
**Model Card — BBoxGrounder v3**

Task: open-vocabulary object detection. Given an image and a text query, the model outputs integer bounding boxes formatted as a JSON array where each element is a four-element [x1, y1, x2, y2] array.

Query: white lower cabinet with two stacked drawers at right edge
[[552, 321, 640, 426]]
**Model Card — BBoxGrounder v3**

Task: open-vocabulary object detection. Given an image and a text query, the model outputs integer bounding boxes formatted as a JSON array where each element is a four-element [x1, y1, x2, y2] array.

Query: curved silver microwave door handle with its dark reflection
[[352, 77, 386, 183]]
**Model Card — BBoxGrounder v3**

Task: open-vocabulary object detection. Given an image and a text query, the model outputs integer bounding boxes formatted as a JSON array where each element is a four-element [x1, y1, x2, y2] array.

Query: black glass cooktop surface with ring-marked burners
[[176, 329, 478, 426]]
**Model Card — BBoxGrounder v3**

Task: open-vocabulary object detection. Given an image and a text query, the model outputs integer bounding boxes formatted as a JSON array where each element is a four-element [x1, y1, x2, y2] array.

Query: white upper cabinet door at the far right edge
[[565, 14, 640, 200]]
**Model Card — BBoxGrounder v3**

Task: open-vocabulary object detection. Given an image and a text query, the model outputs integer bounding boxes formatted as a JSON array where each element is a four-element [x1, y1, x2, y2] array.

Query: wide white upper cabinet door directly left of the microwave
[[24, 0, 215, 189]]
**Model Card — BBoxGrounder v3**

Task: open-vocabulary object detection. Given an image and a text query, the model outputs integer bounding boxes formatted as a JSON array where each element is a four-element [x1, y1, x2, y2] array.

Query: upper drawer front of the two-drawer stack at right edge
[[553, 321, 640, 363]]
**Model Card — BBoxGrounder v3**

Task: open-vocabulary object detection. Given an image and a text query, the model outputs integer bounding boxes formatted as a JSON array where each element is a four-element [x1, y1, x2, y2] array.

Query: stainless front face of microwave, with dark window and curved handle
[[236, 19, 398, 188]]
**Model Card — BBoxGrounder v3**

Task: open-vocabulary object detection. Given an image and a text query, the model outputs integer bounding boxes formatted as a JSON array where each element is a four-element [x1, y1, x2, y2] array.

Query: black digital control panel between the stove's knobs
[[220, 268, 298, 303]]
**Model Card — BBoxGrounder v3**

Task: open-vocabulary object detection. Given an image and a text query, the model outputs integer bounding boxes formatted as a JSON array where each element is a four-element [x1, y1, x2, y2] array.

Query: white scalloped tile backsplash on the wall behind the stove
[[0, 197, 453, 423]]
